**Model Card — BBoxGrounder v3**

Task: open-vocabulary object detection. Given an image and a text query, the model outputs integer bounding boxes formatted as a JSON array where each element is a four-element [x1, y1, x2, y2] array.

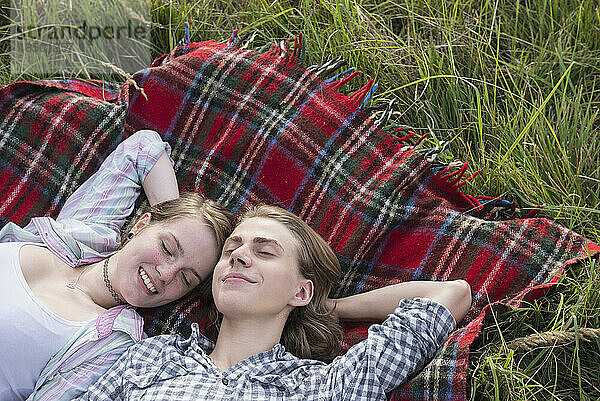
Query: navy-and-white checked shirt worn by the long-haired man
[[72, 299, 456, 401]]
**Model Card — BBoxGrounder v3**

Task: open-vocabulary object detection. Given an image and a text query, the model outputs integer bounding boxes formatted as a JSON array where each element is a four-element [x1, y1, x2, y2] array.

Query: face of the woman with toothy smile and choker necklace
[[110, 213, 218, 307]]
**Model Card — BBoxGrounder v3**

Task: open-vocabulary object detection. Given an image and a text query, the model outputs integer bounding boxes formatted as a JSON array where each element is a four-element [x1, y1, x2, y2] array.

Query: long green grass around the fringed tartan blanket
[[0, 0, 600, 401]]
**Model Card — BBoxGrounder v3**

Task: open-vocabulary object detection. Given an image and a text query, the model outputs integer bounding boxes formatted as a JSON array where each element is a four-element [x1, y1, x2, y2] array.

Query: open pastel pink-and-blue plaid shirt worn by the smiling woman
[[0, 130, 171, 400]]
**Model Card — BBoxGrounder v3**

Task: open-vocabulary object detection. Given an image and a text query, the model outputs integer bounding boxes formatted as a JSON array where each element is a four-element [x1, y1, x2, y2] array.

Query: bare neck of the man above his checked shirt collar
[[209, 316, 287, 371]]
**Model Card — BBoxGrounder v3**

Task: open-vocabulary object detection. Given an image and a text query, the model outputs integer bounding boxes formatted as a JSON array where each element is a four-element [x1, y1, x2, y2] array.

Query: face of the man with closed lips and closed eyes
[[212, 217, 312, 317]]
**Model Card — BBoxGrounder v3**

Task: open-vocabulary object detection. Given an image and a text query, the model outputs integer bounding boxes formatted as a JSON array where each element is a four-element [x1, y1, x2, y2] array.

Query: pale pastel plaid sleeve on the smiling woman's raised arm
[[25, 130, 171, 266]]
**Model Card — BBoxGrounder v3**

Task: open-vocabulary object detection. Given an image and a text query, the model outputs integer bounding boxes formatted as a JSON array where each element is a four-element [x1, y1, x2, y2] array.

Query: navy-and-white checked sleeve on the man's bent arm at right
[[324, 298, 456, 400]]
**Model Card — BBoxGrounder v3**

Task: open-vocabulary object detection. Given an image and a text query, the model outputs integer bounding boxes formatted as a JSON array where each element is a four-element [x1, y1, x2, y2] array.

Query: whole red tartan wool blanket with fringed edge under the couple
[[0, 33, 600, 400]]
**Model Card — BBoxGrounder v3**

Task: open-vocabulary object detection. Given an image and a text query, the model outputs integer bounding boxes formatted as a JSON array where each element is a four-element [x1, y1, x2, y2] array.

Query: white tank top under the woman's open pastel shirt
[[0, 242, 86, 401]]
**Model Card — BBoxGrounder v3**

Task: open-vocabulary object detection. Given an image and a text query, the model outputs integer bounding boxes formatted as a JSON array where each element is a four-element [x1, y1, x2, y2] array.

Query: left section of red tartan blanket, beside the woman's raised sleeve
[[0, 81, 127, 225]]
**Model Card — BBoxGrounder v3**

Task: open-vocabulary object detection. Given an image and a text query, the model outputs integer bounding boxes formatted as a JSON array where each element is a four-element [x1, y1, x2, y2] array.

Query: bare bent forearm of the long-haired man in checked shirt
[[328, 280, 471, 322]]
